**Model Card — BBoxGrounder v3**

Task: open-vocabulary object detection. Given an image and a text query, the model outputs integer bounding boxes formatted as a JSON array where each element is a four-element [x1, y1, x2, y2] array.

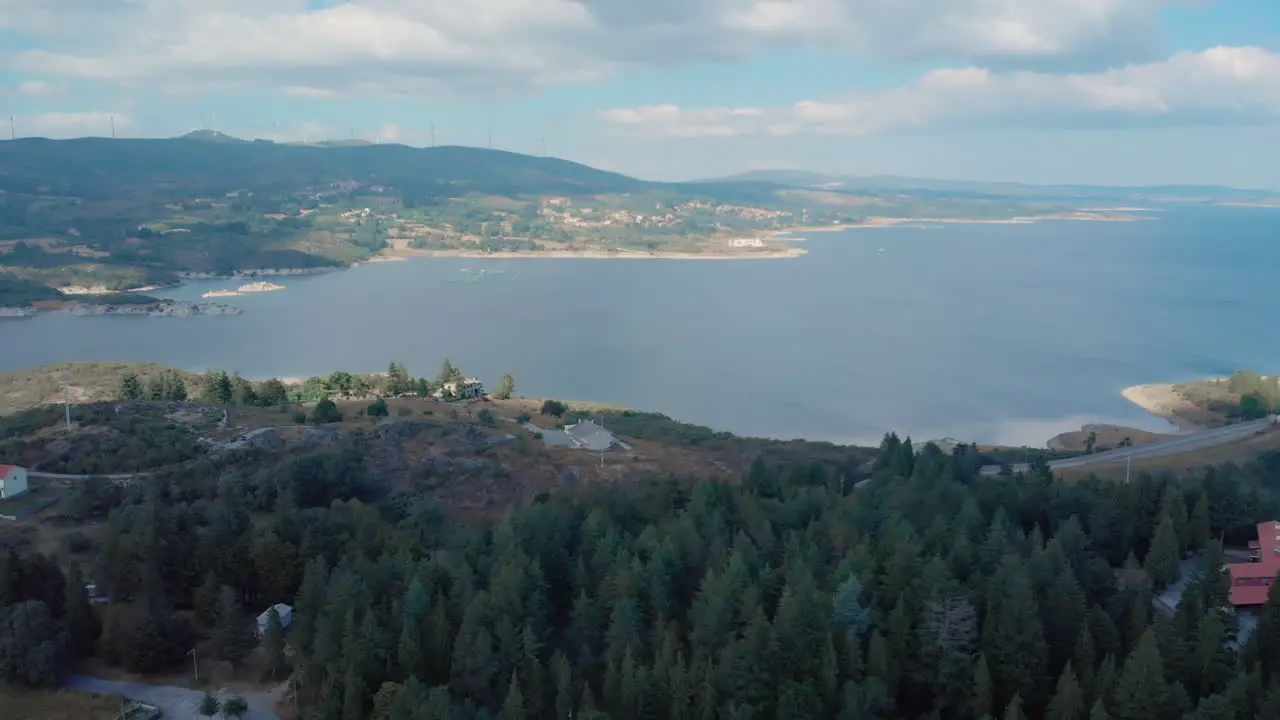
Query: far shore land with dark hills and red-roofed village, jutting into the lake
[[0, 133, 1213, 309]]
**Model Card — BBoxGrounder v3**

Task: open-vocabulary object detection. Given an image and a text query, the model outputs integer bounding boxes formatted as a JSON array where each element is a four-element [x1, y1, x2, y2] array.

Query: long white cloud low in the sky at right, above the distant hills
[[599, 47, 1280, 137]]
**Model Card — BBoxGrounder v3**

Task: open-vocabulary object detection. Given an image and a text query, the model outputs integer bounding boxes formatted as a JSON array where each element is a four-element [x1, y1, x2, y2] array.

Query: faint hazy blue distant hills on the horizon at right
[[699, 170, 1280, 201]]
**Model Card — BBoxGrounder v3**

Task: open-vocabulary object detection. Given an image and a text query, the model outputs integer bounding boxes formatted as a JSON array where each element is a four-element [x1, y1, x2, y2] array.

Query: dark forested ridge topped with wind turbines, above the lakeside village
[[0, 136, 774, 200]]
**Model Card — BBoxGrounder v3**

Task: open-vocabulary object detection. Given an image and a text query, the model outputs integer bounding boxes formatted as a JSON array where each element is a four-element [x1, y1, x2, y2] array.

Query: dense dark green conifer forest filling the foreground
[[0, 412, 1280, 720]]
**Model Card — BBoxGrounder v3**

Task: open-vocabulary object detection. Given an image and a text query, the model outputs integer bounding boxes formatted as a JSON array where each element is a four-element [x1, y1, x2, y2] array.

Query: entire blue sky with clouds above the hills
[[0, 0, 1280, 190]]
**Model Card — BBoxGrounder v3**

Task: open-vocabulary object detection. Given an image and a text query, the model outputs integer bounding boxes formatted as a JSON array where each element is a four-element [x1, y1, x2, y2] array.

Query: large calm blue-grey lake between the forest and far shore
[[0, 208, 1280, 445]]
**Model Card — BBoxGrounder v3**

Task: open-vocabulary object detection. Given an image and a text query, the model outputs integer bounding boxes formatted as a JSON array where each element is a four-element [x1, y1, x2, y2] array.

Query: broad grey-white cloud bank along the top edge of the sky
[[0, 0, 1174, 97]]
